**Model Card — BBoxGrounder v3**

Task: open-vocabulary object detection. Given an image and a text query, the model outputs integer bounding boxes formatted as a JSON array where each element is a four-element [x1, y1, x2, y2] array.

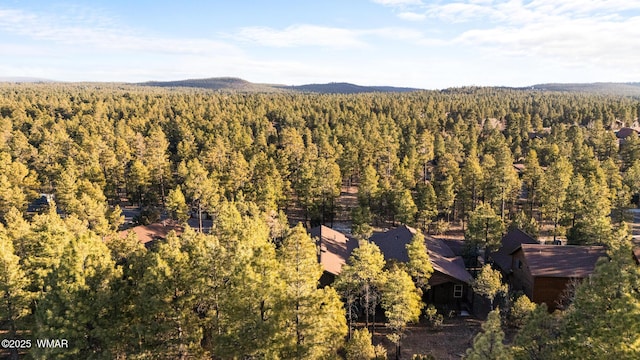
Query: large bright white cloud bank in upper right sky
[[416, 0, 640, 72]]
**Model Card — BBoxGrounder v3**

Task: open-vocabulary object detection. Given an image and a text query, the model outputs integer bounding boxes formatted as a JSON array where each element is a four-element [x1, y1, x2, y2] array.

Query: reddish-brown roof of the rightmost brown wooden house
[[512, 244, 607, 279]]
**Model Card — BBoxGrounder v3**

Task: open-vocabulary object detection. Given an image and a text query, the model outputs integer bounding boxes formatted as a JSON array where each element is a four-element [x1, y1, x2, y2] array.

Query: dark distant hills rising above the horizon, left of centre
[[136, 77, 420, 94]]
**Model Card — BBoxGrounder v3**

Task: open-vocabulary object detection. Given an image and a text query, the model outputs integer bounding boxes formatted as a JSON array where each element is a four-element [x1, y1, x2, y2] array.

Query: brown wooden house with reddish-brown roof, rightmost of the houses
[[510, 243, 607, 311]]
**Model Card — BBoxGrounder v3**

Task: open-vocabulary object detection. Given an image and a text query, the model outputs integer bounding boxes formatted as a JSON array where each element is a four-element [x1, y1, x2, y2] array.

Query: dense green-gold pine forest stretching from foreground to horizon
[[0, 84, 640, 359]]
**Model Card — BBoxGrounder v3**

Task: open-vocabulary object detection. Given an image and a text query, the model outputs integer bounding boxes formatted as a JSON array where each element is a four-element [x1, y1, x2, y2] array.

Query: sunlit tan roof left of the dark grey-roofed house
[[309, 225, 358, 275]]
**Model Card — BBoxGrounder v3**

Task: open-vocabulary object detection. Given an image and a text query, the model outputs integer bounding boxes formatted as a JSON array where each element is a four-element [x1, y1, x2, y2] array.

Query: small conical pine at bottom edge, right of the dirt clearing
[[465, 309, 513, 360]]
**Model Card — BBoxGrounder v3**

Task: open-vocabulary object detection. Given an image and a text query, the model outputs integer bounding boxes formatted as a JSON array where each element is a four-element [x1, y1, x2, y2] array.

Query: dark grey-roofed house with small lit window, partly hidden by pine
[[370, 225, 473, 310]]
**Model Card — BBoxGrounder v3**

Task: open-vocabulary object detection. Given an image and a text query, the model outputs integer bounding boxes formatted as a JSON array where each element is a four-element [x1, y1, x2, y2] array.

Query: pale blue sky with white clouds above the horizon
[[0, 0, 640, 89]]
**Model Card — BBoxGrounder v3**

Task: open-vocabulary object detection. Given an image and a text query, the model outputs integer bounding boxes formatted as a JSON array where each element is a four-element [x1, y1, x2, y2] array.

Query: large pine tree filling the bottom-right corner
[[554, 238, 640, 359]]
